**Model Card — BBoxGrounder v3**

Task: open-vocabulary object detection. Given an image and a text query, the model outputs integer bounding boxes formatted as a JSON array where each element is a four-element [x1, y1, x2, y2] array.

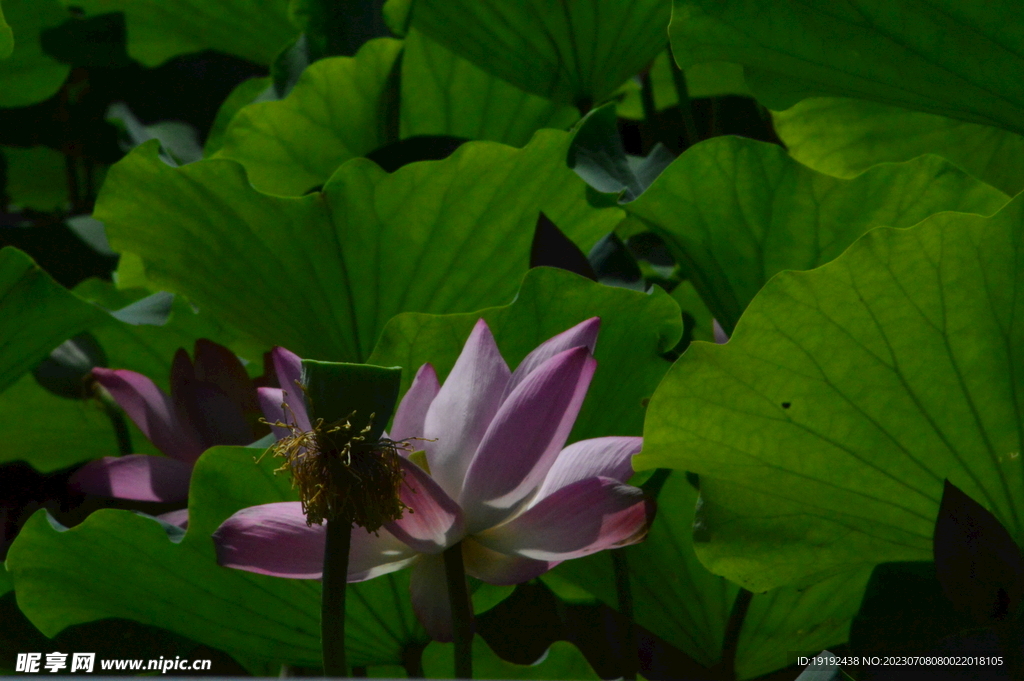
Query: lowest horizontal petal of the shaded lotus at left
[[68, 454, 193, 502]]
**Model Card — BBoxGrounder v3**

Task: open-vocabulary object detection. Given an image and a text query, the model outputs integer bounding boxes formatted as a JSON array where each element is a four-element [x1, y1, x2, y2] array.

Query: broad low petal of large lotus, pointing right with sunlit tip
[[475, 477, 654, 560]]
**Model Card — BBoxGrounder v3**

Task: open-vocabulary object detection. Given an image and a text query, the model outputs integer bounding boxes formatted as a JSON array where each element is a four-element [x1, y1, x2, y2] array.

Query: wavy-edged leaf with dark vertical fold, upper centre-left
[[217, 30, 578, 196]]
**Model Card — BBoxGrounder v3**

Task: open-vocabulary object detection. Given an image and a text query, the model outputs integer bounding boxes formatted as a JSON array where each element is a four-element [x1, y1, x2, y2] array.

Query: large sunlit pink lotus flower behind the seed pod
[[214, 317, 653, 641]]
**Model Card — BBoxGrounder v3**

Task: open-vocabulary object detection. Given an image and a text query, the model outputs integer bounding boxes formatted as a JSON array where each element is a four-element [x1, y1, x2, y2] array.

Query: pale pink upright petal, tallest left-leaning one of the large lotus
[[423, 320, 511, 499]]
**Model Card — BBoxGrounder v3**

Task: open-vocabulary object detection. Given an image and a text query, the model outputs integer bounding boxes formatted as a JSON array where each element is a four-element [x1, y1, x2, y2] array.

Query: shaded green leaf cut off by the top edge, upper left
[[59, 0, 299, 67]]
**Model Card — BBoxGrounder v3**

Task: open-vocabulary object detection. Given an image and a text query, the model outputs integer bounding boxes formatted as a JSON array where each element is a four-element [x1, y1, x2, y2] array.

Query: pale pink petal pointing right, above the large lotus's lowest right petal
[[530, 437, 643, 506]]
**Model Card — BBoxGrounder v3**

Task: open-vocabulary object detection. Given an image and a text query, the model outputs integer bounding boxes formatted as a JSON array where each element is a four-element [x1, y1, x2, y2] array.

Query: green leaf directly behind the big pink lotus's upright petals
[[369, 267, 682, 441]]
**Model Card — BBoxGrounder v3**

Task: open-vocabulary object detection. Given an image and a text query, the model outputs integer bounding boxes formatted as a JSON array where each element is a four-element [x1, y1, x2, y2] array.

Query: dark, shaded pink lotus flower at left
[[70, 339, 268, 524]]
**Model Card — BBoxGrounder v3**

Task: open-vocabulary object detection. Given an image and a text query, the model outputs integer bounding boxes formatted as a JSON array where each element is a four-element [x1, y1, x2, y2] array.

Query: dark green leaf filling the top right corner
[[670, 0, 1024, 132]]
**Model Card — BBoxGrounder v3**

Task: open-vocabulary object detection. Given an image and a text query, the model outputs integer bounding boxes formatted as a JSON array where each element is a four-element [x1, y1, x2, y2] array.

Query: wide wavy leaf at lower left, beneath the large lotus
[[7, 448, 428, 667]]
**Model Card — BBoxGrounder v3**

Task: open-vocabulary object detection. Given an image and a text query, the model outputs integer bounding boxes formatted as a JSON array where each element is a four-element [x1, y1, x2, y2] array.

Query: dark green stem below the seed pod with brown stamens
[[321, 518, 352, 677]]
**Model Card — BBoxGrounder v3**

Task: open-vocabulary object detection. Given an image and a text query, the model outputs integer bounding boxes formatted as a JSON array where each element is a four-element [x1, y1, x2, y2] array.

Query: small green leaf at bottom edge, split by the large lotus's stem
[[423, 636, 600, 681]]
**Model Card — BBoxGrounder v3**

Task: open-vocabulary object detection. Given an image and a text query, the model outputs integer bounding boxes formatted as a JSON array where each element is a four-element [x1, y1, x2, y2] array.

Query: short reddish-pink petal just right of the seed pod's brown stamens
[[387, 459, 465, 553]]
